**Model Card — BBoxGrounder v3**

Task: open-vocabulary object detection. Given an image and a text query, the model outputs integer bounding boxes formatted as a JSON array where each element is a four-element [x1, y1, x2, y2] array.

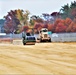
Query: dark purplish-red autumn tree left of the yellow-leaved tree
[[4, 10, 20, 33]]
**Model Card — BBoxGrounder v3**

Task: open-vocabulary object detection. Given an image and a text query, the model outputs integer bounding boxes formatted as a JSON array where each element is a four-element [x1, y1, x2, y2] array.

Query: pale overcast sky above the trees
[[0, 0, 75, 18]]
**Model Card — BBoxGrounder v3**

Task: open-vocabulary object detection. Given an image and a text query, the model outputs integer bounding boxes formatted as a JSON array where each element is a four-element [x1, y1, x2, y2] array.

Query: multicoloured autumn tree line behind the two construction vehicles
[[4, 1, 76, 34]]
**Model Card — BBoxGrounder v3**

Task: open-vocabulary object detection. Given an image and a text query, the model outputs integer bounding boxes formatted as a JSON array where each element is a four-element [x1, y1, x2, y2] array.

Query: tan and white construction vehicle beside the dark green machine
[[37, 28, 51, 42]]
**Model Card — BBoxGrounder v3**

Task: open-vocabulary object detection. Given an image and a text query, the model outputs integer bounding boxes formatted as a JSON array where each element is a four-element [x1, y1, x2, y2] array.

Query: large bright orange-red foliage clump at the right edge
[[52, 18, 76, 33]]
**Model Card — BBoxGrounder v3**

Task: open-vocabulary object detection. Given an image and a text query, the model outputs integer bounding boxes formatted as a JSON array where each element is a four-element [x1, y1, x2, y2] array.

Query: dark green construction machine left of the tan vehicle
[[22, 28, 36, 45]]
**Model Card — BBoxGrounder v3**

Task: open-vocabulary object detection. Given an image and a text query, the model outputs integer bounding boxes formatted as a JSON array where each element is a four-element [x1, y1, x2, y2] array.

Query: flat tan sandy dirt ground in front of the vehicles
[[0, 43, 76, 75]]
